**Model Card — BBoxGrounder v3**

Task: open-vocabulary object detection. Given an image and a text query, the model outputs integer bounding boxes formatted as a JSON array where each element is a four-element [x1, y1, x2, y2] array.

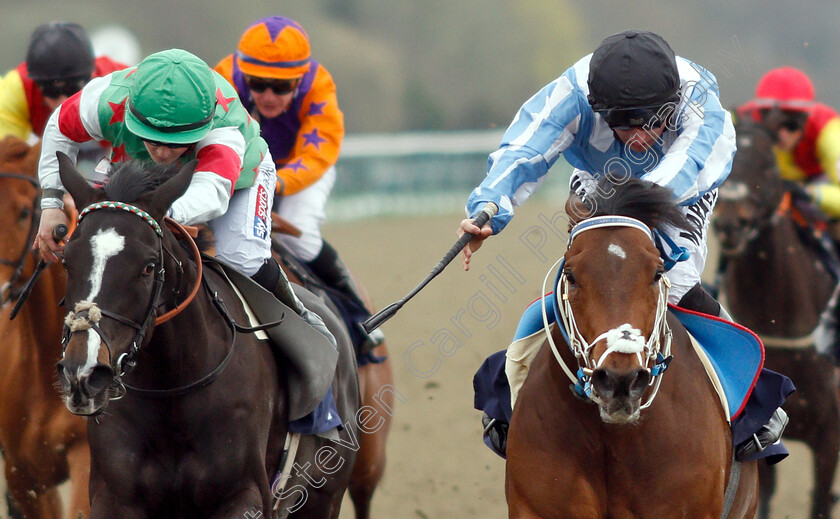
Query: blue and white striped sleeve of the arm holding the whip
[[466, 71, 585, 234]]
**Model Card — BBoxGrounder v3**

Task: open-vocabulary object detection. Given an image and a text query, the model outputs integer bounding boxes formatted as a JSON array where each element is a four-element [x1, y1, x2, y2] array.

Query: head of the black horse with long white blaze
[[57, 153, 196, 415]]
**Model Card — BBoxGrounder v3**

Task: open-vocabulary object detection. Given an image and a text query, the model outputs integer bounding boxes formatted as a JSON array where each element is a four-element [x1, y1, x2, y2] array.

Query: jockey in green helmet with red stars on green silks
[[35, 49, 335, 352]]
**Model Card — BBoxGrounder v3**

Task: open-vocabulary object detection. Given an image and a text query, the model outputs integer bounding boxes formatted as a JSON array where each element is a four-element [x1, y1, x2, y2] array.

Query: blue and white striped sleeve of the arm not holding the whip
[[642, 58, 736, 205]]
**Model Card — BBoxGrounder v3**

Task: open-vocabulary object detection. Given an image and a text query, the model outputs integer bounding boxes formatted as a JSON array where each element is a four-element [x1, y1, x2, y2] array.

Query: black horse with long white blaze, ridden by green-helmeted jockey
[[57, 153, 359, 519]]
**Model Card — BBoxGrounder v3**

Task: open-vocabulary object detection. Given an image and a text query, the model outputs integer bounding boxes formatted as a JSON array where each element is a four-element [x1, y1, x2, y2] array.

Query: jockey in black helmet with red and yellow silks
[[0, 22, 126, 140]]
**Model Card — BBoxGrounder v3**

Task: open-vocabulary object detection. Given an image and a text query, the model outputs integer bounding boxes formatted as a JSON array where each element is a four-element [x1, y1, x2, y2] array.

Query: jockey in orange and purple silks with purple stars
[[216, 16, 382, 351]]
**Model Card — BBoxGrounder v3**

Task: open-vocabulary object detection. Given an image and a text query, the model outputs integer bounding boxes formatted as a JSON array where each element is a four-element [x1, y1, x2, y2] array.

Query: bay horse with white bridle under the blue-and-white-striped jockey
[[505, 179, 758, 519]]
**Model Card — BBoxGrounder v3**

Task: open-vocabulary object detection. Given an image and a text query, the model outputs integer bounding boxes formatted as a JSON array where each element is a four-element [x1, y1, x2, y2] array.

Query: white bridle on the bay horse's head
[[541, 216, 673, 409]]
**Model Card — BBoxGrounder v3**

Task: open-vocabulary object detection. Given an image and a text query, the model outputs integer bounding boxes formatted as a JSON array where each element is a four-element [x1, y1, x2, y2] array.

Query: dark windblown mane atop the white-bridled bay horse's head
[[585, 177, 690, 235]]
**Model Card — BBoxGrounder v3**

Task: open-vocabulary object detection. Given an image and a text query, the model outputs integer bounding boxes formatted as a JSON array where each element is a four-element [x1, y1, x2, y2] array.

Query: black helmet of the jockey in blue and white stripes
[[588, 30, 680, 128]]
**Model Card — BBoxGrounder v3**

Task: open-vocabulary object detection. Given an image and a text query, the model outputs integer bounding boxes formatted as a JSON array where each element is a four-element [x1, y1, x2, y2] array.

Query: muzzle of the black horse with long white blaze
[[56, 360, 114, 416]]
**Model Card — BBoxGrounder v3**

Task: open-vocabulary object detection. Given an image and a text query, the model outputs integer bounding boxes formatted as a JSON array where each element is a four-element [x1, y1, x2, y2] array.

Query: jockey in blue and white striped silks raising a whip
[[458, 30, 782, 460]]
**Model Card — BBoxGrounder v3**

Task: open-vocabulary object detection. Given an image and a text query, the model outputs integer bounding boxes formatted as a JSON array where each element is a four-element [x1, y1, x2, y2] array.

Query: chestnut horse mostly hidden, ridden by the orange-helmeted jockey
[[272, 231, 394, 519]]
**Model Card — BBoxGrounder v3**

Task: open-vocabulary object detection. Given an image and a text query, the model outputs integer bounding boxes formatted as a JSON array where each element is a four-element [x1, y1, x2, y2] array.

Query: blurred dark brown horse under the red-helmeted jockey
[[713, 120, 840, 519]]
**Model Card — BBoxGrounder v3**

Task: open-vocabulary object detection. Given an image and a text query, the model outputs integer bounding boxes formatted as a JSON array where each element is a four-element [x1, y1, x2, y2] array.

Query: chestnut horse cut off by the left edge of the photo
[[0, 137, 90, 519]]
